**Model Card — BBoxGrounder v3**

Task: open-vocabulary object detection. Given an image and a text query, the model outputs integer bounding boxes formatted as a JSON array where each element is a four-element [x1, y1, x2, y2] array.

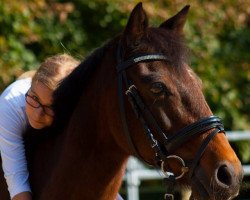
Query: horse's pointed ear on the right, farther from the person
[[160, 5, 190, 35]]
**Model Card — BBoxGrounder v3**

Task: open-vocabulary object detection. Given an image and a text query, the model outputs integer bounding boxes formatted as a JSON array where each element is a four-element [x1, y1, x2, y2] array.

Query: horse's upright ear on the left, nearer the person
[[123, 2, 148, 45]]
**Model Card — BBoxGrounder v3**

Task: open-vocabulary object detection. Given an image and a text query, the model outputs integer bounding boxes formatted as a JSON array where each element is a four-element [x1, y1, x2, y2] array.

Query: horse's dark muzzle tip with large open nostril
[[190, 162, 243, 200]]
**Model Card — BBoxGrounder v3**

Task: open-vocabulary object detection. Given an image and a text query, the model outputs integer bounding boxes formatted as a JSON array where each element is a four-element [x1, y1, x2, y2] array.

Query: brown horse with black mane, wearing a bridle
[[0, 3, 243, 200]]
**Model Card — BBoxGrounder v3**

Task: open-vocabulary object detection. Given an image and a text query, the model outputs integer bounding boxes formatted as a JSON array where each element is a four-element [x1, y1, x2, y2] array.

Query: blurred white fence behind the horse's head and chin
[[124, 131, 250, 200]]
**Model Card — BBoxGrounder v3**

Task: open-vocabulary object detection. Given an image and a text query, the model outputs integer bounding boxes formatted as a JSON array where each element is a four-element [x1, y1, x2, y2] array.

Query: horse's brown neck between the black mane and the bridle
[[40, 45, 128, 200]]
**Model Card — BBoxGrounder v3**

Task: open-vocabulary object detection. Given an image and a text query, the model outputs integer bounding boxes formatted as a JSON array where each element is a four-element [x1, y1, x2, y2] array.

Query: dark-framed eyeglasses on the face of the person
[[25, 92, 55, 117]]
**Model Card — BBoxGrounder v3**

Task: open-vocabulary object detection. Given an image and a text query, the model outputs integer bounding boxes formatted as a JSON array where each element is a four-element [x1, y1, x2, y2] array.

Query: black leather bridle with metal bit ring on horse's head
[[116, 45, 224, 199]]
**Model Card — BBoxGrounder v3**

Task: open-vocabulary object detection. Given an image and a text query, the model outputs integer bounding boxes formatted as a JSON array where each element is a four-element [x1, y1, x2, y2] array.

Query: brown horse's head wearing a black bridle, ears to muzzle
[[114, 3, 243, 199]]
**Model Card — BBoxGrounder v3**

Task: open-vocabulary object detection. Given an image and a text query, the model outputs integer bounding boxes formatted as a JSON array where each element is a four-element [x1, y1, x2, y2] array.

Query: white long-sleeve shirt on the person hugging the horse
[[0, 78, 31, 198]]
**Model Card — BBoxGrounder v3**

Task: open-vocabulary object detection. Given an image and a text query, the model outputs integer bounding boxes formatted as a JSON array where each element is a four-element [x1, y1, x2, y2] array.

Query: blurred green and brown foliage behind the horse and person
[[0, 0, 250, 199]]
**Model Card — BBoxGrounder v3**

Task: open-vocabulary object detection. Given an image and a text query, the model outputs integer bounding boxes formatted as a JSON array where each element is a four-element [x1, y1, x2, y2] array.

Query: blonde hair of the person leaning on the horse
[[32, 54, 80, 91]]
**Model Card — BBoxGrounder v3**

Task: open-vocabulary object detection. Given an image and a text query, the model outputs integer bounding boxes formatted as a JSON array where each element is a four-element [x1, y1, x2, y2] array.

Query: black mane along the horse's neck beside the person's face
[[52, 41, 115, 129]]
